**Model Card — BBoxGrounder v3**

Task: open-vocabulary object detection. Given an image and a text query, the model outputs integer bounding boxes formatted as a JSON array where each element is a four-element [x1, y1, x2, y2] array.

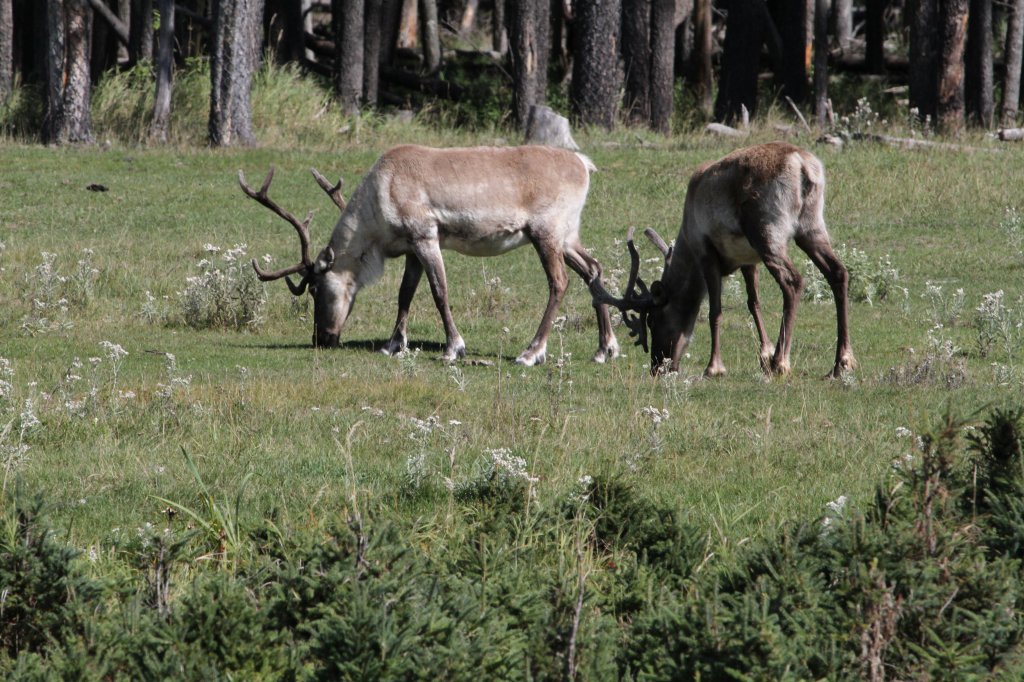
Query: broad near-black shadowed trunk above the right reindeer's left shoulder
[[715, 0, 765, 123]]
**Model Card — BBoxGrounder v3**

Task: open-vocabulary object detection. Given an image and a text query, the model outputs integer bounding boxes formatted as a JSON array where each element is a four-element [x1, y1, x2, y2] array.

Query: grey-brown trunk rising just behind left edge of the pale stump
[[508, 0, 551, 128]]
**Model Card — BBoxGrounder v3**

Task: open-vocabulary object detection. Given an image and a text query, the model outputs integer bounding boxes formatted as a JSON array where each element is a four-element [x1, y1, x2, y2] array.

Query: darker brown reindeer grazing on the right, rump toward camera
[[590, 142, 856, 378]]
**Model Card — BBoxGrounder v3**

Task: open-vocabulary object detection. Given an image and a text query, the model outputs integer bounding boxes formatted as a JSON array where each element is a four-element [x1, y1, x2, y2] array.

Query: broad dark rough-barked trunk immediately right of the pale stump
[[569, 0, 623, 130]]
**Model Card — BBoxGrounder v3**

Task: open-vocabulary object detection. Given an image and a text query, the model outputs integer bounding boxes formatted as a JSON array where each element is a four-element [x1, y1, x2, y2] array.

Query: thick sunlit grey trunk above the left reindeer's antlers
[[209, 0, 263, 146]]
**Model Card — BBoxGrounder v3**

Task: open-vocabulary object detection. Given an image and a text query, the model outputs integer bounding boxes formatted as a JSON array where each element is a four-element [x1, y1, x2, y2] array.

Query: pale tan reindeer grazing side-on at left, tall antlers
[[239, 145, 618, 367]]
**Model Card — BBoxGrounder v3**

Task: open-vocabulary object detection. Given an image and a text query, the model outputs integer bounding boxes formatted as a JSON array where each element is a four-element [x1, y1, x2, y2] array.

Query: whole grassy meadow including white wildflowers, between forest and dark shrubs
[[0, 93, 1024, 677]]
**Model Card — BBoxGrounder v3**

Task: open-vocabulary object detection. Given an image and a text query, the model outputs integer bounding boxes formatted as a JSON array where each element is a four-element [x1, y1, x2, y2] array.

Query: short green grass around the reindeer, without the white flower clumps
[[0, 125, 1024, 547]]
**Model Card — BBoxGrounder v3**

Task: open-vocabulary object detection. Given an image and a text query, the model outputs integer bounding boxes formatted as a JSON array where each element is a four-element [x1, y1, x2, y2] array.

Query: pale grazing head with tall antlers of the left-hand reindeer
[[239, 168, 355, 348]]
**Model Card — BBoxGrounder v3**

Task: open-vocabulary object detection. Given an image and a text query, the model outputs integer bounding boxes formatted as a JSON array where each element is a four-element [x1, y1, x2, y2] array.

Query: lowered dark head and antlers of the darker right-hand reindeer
[[590, 227, 685, 375]]
